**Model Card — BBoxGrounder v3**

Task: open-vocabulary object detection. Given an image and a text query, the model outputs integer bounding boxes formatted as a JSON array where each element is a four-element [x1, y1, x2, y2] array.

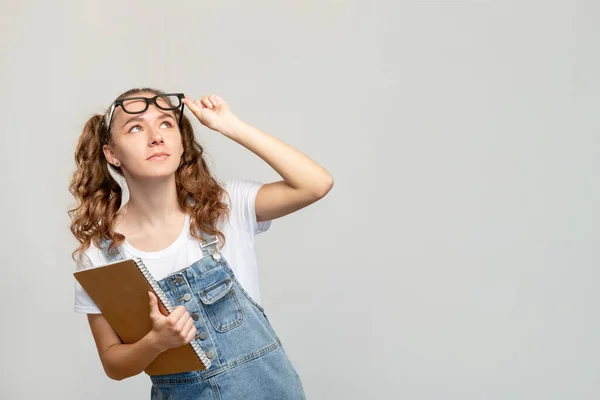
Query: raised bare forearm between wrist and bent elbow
[[221, 120, 333, 194]]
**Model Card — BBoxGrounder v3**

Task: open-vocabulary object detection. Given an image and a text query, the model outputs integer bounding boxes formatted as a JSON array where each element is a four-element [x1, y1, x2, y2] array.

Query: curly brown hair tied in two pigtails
[[68, 88, 229, 261]]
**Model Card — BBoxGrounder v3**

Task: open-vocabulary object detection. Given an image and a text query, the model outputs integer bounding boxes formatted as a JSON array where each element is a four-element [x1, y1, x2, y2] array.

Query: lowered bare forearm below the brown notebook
[[104, 332, 164, 381]]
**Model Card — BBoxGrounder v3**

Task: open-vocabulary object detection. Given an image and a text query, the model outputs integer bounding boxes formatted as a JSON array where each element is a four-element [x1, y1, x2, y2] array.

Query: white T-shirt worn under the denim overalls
[[75, 180, 272, 314]]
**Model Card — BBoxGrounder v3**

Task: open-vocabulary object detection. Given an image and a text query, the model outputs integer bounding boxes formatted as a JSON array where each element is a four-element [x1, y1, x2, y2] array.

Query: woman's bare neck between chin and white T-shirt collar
[[120, 175, 184, 229]]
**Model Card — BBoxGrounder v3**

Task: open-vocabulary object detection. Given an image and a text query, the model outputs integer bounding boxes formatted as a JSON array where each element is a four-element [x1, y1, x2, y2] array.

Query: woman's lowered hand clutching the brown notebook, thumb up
[[148, 292, 196, 351]]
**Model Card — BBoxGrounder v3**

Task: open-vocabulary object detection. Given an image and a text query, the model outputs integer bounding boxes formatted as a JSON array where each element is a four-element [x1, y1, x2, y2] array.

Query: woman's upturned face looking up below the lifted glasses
[[104, 92, 183, 178]]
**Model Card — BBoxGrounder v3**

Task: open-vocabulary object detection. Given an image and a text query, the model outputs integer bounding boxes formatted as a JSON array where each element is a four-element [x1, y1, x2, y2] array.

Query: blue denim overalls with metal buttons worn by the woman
[[101, 233, 306, 400]]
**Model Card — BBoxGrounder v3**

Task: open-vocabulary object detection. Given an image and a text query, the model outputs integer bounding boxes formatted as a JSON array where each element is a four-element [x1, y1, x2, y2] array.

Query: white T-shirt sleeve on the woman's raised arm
[[226, 180, 272, 236]]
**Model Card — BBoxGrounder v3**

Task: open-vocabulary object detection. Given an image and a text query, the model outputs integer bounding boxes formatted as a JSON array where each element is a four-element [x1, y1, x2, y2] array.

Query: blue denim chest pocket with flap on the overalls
[[198, 277, 244, 332]]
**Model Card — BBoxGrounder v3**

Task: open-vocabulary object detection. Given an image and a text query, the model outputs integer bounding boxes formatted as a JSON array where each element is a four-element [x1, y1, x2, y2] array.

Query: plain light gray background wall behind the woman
[[0, 0, 600, 400]]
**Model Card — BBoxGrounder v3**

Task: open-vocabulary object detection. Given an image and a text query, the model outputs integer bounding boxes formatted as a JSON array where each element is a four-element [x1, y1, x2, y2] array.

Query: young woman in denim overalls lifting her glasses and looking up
[[69, 88, 333, 400]]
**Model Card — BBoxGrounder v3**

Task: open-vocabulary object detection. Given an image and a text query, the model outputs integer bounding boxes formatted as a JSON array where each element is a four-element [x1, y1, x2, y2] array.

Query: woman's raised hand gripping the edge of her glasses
[[183, 94, 239, 135]]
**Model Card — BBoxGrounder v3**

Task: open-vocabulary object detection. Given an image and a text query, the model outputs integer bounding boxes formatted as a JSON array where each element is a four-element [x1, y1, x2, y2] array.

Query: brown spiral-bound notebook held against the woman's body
[[73, 258, 210, 375]]
